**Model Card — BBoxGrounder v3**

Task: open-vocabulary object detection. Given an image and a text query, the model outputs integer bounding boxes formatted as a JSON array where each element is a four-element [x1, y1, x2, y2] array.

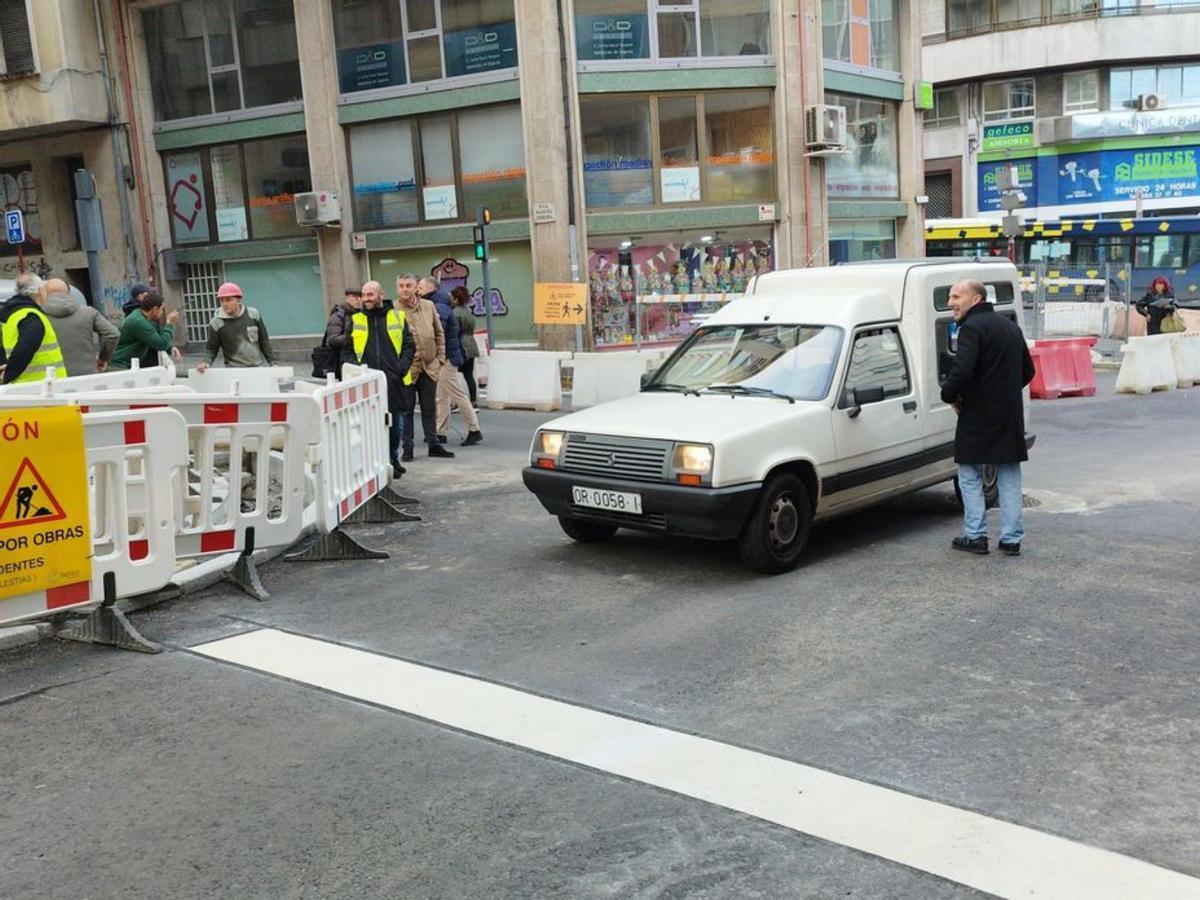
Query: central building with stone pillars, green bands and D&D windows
[[0, 0, 922, 348]]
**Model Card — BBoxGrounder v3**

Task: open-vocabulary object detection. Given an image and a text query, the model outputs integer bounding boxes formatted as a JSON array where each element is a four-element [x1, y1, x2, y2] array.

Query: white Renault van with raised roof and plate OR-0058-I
[[523, 258, 1032, 574]]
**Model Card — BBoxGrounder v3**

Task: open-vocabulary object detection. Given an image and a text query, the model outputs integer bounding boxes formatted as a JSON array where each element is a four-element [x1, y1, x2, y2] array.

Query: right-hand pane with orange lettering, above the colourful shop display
[[704, 91, 775, 203]]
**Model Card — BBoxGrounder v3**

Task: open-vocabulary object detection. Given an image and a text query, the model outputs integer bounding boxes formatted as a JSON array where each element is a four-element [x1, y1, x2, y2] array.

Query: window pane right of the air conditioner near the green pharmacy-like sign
[[826, 94, 900, 199]]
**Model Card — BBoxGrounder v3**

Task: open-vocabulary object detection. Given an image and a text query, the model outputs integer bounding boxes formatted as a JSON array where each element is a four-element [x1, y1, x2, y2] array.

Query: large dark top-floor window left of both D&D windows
[[142, 0, 301, 121]]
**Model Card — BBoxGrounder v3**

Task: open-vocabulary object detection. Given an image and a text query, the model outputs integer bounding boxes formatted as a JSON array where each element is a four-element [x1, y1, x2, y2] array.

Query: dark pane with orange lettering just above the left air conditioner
[[242, 134, 312, 238]]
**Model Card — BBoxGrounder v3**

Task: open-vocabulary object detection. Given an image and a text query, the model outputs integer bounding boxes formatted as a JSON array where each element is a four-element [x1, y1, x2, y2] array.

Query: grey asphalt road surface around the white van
[[0, 377, 1200, 898]]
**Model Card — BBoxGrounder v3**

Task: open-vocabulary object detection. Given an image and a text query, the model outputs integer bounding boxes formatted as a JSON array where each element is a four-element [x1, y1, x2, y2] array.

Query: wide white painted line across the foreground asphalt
[[192, 629, 1200, 900]]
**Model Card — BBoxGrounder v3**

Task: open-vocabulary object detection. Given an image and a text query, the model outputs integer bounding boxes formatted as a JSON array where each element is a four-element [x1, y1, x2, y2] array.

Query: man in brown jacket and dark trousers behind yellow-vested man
[[396, 272, 454, 462]]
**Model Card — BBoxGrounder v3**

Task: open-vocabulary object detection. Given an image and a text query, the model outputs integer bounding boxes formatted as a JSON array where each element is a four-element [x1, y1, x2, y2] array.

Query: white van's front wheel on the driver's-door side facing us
[[738, 474, 812, 575]]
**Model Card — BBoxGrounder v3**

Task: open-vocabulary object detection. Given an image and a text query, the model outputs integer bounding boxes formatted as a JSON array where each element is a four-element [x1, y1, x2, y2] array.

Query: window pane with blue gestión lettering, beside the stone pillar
[[580, 96, 654, 208]]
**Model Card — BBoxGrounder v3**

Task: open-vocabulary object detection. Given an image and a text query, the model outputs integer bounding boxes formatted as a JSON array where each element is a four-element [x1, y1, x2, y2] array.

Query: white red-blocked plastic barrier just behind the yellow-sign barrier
[[0, 392, 320, 557]]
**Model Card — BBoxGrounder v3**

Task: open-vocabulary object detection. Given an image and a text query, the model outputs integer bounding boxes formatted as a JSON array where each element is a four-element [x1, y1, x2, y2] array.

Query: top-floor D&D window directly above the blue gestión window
[[575, 0, 770, 61]]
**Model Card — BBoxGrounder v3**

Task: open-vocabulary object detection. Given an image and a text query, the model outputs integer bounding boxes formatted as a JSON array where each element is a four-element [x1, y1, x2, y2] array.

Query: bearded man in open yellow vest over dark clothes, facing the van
[[350, 281, 416, 478]]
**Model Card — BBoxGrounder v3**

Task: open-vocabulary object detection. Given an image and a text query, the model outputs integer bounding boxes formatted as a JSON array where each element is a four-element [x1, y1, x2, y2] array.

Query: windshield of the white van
[[646, 324, 842, 400]]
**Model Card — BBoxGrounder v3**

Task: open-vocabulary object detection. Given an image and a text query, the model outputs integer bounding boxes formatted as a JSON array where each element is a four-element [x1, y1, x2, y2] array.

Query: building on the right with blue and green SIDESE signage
[[923, 0, 1200, 225]]
